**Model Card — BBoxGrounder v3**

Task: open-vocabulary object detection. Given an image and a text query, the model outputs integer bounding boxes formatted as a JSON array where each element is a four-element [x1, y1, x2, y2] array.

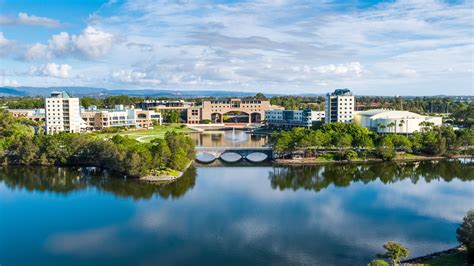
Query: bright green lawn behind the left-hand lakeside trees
[[94, 124, 194, 142]]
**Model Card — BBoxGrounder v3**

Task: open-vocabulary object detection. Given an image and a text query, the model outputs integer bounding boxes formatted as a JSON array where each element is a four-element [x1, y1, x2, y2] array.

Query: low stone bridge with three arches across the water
[[196, 147, 273, 163]]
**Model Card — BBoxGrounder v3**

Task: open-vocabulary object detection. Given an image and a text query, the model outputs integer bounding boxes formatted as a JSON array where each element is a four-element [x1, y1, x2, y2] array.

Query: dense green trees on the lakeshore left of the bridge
[[0, 112, 195, 177]]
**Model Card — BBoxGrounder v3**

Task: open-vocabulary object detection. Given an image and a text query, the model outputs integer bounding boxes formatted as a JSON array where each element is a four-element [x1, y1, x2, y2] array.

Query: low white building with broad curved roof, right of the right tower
[[355, 109, 442, 134]]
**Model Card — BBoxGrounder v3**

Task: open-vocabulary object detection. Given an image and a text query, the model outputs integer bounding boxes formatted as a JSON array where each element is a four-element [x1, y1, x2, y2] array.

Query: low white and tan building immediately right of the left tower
[[81, 105, 163, 131]]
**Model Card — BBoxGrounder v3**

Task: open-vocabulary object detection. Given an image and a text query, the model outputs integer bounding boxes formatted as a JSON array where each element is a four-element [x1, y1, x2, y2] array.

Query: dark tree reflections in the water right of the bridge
[[269, 159, 474, 191]]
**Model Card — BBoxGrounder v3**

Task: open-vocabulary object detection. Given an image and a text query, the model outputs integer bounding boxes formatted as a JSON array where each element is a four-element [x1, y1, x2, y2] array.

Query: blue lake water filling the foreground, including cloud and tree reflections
[[0, 160, 474, 265]]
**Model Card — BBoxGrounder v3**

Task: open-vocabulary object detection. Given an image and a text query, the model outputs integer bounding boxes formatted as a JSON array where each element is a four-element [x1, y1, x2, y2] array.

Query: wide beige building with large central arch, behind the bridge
[[187, 98, 283, 124]]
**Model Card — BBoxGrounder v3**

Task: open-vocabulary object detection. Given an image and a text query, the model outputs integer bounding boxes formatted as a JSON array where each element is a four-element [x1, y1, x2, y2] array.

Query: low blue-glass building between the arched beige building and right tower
[[265, 109, 324, 128]]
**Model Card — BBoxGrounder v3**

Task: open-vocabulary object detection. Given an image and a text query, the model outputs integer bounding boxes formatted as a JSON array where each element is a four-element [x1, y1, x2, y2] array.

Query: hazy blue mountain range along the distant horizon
[[0, 87, 474, 98]]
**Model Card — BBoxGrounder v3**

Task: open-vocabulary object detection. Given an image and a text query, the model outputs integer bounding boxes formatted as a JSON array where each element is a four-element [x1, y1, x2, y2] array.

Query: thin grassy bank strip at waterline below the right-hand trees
[[273, 154, 474, 165]]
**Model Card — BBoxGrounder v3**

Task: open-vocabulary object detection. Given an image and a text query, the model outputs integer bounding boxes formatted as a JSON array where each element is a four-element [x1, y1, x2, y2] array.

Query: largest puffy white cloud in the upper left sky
[[24, 26, 114, 61]]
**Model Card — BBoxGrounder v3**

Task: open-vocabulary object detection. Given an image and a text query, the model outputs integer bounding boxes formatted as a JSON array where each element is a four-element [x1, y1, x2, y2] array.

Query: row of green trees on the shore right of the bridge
[[269, 123, 474, 161]]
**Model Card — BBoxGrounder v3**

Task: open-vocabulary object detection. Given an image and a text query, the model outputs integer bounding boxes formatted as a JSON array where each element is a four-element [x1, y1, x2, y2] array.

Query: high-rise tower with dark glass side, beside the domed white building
[[324, 89, 355, 123]]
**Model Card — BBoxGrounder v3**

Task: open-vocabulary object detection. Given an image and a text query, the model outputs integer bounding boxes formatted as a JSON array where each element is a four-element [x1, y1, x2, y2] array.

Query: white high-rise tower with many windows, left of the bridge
[[45, 92, 85, 134]]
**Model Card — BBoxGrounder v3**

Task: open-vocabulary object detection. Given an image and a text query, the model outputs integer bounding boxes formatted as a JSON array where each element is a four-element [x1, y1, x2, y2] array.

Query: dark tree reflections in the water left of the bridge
[[0, 166, 196, 200]]
